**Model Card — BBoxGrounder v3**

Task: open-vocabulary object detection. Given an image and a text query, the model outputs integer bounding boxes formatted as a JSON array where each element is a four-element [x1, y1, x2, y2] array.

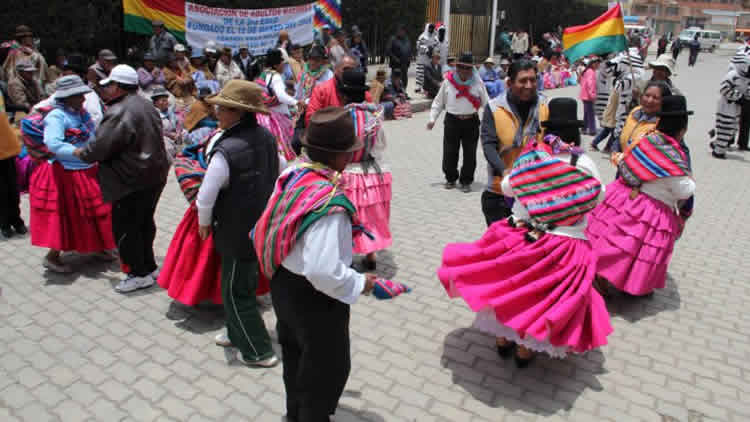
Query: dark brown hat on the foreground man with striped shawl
[[302, 107, 365, 152]]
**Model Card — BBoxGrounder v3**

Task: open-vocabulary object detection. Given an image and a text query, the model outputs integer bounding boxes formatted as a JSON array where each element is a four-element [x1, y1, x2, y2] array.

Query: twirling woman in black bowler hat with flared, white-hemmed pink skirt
[[438, 98, 612, 367]]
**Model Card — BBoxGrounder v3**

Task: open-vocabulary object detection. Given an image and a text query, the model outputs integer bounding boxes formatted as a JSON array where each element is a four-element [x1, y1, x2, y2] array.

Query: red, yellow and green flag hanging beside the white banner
[[122, 0, 185, 41]]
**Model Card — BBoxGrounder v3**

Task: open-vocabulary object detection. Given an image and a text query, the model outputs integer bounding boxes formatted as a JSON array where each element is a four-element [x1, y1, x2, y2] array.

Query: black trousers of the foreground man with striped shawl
[[271, 267, 351, 422]]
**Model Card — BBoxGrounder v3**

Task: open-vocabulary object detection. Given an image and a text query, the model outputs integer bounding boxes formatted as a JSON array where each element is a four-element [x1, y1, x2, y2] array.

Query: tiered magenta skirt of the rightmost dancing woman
[[586, 179, 682, 296]]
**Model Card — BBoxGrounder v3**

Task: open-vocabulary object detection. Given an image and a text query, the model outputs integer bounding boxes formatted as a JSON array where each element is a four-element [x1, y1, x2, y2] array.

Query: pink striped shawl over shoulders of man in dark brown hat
[[250, 162, 370, 280]]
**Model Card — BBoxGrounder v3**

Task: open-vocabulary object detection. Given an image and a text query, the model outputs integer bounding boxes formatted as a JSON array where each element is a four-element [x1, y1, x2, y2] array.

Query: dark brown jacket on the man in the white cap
[[80, 94, 169, 202]]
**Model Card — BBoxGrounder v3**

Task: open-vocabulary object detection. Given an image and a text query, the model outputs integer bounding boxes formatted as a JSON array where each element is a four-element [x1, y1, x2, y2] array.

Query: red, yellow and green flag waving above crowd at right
[[563, 3, 628, 63]]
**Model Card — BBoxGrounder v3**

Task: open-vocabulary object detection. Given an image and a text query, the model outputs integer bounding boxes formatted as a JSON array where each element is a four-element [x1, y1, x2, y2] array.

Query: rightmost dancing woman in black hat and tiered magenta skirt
[[586, 96, 695, 296]]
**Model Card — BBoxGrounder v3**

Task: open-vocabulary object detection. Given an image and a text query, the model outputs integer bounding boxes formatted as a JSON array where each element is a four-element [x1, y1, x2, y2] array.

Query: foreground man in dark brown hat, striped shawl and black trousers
[[253, 107, 390, 422]]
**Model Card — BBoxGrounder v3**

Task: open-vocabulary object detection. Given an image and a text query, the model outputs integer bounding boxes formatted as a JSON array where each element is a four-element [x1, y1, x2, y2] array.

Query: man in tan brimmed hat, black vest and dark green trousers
[[196, 79, 279, 368]]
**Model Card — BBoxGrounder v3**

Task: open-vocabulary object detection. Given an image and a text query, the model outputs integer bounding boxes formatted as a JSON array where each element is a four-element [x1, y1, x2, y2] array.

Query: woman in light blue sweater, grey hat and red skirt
[[29, 75, 116, 273]]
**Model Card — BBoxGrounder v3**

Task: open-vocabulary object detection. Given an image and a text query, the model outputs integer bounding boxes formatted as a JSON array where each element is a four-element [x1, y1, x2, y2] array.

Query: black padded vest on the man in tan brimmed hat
[[211, 117, 279, 260]]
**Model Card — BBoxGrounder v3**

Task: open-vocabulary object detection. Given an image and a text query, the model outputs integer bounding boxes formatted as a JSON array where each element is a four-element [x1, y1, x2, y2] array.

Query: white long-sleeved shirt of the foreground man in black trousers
[[281, 213, 365, 305]]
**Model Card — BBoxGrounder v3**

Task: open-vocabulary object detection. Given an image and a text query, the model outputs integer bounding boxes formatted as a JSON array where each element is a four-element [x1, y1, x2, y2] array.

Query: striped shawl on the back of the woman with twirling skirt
[[510, 135, 602, 228]]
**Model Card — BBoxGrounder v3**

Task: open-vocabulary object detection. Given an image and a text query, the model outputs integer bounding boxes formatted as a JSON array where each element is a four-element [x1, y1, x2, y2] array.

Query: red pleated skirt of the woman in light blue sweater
[[29, 161, 115, 253]]
